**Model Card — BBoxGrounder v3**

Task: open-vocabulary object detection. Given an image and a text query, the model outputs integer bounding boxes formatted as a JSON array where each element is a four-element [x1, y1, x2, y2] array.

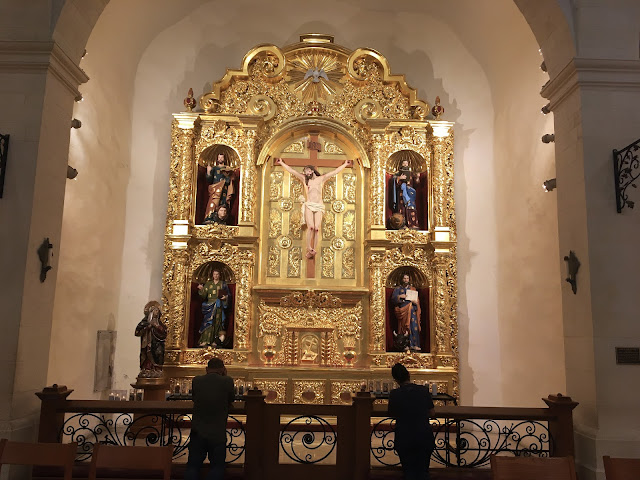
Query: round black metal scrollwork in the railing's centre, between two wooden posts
[[280, 415, 337, 464]]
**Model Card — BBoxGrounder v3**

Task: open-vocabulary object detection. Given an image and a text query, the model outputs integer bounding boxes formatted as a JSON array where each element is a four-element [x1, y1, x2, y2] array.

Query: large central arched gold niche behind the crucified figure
[[258, 123, 367, 288]]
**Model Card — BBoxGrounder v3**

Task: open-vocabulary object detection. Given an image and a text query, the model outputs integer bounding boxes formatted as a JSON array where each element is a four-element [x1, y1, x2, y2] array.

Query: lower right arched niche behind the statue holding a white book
[[385, 266, 431, 353]]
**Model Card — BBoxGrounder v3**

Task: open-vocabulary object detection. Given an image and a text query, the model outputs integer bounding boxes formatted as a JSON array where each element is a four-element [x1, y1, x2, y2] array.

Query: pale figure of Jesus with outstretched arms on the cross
[[275, 158, 353, 258]]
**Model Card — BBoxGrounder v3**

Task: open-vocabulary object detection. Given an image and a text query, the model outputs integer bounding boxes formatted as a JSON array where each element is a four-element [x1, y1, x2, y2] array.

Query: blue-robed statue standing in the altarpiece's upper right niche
[[389, 159, 420, 230]]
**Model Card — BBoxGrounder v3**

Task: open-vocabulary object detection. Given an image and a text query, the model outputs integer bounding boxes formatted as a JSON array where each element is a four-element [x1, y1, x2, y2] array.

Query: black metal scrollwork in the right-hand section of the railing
[[371, 418, 553, 468]]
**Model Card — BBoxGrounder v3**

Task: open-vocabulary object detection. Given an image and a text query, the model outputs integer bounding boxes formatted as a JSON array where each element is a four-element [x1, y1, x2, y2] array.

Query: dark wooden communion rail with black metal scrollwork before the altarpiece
[[39, 386, 577, 480]]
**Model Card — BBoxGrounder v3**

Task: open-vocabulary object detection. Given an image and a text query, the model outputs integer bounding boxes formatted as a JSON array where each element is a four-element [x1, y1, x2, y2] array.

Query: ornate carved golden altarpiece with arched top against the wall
[[163, 34, 459, 403]]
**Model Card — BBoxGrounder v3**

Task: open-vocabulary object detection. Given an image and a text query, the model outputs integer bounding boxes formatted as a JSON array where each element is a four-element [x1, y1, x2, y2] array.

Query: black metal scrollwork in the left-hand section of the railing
[[60, 413, 245, 463]]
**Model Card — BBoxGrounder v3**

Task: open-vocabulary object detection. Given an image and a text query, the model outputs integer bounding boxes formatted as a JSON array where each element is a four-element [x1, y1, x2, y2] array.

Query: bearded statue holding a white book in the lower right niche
[[391, 273, 422, 352]]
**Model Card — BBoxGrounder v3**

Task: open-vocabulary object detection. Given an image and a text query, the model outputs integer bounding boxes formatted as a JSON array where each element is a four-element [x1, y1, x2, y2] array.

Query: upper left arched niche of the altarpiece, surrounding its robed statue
[[194, 144, 240, 225]]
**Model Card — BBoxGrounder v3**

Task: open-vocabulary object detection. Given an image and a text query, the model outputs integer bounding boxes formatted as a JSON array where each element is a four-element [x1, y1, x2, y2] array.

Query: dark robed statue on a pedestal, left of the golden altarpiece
[[135, 300, 167, 378]]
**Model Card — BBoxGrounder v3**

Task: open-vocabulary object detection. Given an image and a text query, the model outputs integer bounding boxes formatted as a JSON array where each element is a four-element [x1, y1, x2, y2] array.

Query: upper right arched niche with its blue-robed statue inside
[[385, 150, 430, 230]]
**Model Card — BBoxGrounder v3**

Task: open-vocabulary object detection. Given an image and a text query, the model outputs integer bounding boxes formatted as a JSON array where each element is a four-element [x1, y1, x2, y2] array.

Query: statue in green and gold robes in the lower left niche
[[198, 270, 231, 348]]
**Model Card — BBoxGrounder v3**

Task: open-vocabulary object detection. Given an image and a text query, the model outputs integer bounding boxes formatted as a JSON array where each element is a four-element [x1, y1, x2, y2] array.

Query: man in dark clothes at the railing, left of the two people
[[184, 358, 234, 480]]
